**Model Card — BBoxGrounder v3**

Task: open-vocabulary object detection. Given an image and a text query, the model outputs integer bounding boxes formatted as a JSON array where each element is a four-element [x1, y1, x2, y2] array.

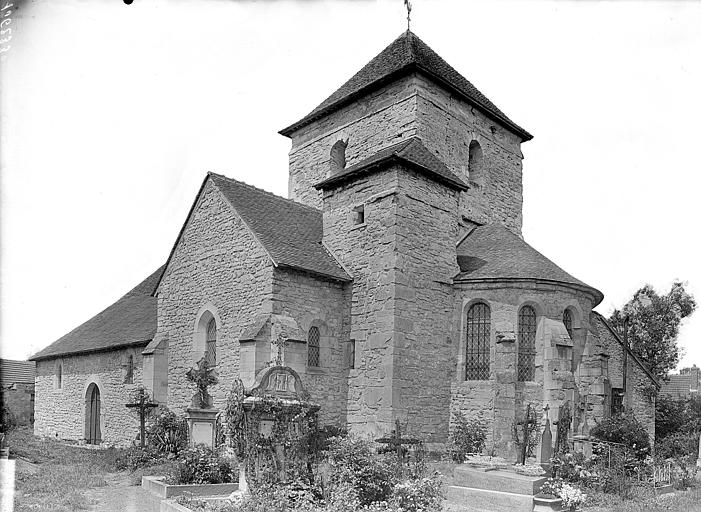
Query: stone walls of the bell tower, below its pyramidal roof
[[289, 74, 523, 234]]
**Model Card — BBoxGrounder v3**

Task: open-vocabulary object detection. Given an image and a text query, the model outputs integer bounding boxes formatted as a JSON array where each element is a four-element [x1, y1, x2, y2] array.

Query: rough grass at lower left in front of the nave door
[[8, 428, 121, 512]]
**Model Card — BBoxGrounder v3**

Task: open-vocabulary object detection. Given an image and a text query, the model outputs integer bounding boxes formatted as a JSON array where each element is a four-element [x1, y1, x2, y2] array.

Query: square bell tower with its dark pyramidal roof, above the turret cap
[[280, 31, 532, 234]]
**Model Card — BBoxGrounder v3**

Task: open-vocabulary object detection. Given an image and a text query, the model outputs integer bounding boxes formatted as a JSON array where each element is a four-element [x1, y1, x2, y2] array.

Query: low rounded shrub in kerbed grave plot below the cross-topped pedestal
[[176, 445, 238, 484]]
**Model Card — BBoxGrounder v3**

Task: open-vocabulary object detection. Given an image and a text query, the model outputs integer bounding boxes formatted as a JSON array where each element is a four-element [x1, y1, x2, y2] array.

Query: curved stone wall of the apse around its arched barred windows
[[451, 283, 592, 457]]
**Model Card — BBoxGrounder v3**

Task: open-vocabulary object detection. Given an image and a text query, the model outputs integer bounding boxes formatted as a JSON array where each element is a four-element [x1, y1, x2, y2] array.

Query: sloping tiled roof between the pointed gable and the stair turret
[[209, 173, 351, 281]]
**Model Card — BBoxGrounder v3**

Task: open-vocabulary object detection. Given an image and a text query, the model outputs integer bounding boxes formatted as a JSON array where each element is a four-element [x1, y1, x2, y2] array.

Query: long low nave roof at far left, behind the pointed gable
[[29, 266, 165, 361]]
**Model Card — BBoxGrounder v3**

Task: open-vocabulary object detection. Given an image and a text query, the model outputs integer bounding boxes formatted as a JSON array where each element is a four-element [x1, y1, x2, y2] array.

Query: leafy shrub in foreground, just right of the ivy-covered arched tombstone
[[328, 435, 398, 506]]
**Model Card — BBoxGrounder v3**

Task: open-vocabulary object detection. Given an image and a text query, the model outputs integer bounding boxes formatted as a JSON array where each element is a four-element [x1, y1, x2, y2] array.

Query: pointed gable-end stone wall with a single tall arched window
[[156, 180, 273, 413]]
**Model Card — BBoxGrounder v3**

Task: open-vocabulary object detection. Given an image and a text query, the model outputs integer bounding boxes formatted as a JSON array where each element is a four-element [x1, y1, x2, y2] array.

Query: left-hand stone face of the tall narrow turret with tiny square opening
[[323, 168, 399, 434]]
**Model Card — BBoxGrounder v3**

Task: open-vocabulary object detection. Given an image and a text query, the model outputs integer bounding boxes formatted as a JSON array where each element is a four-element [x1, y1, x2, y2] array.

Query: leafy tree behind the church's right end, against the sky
[[609, 282, 696, 380]]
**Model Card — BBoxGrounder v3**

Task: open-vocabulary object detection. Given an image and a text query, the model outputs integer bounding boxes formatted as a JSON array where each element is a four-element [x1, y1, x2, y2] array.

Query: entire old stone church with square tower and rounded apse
[[32, 31, 659, 455]]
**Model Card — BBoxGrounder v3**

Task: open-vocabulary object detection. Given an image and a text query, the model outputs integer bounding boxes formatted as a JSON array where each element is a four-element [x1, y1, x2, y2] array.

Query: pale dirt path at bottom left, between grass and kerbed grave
[[85, 472, 161, 512]]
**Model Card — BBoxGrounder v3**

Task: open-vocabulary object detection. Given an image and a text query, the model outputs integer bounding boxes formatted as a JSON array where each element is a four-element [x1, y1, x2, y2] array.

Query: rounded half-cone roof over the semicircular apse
[[455, 224, 603, 304]]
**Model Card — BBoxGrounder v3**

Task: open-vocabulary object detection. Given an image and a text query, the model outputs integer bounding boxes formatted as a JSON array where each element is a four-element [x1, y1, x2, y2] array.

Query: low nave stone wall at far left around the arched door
[[34, 347, 143, 444]]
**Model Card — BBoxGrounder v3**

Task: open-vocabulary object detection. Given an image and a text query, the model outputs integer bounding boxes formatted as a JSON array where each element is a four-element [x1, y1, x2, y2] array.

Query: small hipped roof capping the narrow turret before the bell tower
[[314, 137, 467, 190]]
